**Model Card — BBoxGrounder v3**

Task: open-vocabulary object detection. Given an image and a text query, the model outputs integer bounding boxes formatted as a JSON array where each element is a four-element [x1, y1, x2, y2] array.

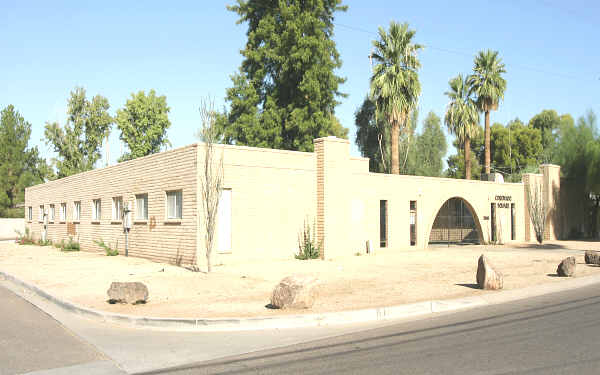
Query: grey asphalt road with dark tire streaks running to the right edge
[[148, 285, 600, 374]]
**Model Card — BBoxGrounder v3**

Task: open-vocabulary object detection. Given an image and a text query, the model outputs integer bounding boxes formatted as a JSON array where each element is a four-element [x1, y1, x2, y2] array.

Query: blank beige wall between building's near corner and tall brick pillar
[[198, 144, 316, 265]]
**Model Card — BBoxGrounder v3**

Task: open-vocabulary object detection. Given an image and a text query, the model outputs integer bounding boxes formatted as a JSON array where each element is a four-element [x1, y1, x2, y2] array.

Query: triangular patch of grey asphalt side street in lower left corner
[[0, 287, 110, 374]]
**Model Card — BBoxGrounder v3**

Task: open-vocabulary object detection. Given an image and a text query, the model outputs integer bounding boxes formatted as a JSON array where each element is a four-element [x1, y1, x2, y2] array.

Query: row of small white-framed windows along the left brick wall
[[27, 190, 183, 222]]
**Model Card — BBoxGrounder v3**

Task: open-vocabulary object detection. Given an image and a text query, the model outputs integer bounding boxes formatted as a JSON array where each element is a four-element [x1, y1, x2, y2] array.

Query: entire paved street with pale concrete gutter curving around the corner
[[0, 282, 600, 375]]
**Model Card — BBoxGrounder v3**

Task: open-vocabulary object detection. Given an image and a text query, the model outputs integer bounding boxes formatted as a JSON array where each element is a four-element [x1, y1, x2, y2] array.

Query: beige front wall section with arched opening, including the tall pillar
[[315, 138, 525, 258]]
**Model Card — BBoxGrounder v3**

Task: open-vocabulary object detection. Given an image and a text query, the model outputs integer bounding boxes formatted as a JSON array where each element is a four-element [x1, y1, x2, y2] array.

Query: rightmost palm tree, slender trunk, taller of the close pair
[[468, 50, 506, 178]]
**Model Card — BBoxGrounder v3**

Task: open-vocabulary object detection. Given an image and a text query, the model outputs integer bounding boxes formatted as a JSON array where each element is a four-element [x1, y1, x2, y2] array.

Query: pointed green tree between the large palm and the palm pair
[[410, 111, 448, 177]]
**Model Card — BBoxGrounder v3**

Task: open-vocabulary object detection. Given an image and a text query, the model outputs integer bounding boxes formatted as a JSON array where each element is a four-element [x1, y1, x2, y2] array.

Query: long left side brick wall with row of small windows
[[25, 145, 197, 263]]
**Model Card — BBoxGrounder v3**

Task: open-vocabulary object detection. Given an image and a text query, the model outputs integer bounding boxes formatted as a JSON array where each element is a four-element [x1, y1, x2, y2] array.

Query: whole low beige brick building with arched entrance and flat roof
[[25, 137, 563, 264]]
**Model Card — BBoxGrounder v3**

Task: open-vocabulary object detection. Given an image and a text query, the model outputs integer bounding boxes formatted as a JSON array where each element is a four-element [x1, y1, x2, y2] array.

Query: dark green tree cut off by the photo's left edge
[[0, 105, 51, 217]]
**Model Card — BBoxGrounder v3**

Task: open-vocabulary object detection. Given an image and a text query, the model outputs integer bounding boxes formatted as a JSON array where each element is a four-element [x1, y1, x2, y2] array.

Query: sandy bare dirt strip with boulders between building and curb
[[0, 241, 600, 318]]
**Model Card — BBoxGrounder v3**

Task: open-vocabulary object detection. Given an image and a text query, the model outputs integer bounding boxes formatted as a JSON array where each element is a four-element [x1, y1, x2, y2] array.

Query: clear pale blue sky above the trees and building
[[0, 0, 600, 164]]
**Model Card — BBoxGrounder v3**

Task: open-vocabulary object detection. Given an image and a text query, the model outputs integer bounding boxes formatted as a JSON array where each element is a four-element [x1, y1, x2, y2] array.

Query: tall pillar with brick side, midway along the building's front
[[314, 137, 351, 259]]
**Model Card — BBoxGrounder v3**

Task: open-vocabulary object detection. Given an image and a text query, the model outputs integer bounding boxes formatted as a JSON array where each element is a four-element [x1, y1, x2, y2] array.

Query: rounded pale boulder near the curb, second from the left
[[271, 275, 321, 309]]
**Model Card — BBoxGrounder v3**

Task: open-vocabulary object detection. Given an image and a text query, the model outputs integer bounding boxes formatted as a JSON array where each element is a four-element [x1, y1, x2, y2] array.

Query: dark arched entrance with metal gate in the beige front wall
[[429, 198, 482, 244]]
